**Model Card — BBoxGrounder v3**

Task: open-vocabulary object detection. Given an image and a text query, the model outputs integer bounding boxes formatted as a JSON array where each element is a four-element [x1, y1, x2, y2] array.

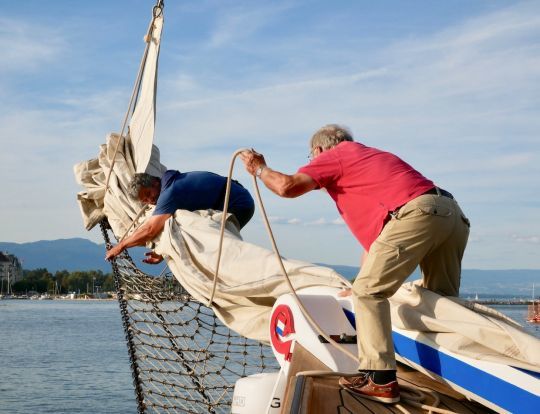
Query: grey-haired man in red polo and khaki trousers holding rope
[[241, 125, 470, 403]]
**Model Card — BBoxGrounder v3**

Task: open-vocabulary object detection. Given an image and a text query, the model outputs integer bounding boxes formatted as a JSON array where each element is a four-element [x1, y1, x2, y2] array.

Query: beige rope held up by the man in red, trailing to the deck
[[207, 148, 456, 414]]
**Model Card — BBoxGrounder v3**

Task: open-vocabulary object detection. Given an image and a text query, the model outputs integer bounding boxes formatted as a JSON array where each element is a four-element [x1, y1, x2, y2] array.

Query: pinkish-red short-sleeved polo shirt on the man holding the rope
[[298, 141, 435, 251]]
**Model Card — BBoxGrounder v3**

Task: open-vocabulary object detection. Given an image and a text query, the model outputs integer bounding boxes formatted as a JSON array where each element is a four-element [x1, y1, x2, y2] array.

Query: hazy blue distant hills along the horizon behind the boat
[[0, 238, 540, 297]]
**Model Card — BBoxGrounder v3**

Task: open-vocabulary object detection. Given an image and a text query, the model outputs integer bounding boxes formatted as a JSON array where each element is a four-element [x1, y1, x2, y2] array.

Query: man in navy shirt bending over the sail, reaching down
[[105, 170, 255, 264]]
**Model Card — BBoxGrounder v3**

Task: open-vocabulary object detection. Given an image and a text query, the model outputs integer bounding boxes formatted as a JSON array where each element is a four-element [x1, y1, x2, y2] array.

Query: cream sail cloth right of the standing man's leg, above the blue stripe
[[390, 281, 540, 372]]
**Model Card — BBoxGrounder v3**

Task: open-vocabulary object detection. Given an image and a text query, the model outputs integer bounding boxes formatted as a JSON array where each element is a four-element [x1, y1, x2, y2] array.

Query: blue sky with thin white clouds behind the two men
[[0, 0, 540, 269]]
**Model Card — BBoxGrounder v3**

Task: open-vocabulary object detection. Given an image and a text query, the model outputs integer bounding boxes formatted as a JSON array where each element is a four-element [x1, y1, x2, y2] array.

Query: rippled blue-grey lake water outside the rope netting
[[0, 300, 540, 414]]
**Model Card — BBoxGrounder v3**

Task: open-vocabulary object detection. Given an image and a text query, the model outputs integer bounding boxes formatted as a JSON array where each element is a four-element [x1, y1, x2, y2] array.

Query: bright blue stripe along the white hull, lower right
[[392, 332, 540, 413]]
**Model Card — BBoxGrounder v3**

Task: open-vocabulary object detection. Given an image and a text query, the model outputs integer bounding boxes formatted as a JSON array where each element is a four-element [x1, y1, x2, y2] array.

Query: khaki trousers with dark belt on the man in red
[[353, 195, 470, 370]]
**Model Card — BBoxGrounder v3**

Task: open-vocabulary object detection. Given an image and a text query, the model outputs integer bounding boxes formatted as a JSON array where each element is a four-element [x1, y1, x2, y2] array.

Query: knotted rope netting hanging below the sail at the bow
[[100, 221, 279, 413]]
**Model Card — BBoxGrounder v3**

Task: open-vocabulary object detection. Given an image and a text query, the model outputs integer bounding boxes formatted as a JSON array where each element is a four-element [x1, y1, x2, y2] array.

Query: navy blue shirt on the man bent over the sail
[[154, 170, 255, 227]]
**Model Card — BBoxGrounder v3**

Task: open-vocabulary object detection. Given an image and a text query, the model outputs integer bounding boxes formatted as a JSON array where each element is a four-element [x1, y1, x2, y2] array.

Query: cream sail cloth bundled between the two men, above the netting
[[155, 210, 350, 343]]
